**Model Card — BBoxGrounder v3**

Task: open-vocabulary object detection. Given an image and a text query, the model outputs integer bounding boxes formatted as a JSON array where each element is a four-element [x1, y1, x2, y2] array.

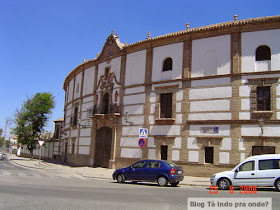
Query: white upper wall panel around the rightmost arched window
[[241, 29, 280, 72]]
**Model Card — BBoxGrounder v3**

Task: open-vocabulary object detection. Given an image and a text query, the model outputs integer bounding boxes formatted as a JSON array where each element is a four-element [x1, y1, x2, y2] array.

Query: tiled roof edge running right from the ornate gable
[[126, 15, 280, 47]]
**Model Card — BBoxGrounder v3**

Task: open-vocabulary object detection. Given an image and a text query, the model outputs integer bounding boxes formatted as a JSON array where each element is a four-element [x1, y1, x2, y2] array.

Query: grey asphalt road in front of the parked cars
[[0, 160, 280, 210]]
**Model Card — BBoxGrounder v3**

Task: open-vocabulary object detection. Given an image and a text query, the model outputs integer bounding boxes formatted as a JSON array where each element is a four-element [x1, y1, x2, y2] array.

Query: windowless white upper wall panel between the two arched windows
[[192, 35, 231, 77]]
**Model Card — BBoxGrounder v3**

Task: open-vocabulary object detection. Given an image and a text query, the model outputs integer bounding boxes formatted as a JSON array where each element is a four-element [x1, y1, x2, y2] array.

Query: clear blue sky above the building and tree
[[0, 0, 280, 137]]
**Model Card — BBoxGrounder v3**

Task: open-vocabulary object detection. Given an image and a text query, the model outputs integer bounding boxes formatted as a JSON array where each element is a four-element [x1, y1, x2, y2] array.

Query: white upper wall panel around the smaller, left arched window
[[152, 42, 184, 82]]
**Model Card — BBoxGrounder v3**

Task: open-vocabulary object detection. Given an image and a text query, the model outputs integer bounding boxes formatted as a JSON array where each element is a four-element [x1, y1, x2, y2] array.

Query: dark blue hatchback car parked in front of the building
[[113, 160, 184, 187]]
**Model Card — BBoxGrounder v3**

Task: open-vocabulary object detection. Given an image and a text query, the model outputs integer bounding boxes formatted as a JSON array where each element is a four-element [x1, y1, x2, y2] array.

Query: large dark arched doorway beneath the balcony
[[94, 127, 112, 168]]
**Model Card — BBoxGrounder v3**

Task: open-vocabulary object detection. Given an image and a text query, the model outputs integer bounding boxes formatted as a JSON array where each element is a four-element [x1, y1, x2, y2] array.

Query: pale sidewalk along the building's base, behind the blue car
[[7, 154, 210, 187]]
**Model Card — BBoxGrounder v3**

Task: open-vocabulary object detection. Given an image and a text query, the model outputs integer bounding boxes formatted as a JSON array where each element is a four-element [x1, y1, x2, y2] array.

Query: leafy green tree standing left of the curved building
[[12, 93, 54, 159]]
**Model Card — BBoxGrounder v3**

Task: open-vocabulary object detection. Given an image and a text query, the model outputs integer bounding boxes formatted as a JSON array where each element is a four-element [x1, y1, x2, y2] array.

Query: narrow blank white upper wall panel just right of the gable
[[125, 50, 146, 86]]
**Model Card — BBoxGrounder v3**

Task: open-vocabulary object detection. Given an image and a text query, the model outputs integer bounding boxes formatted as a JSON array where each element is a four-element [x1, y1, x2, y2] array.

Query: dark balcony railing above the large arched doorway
[[87, 104, 120, 117]]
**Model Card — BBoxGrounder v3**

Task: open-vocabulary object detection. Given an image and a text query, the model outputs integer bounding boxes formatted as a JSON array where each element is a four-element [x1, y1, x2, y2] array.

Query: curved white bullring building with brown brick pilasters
[[60, 16, 280, 168]]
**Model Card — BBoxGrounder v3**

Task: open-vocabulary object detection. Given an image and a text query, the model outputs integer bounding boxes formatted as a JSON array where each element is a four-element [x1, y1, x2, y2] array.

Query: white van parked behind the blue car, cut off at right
[[210, 154, 280, 191]]
